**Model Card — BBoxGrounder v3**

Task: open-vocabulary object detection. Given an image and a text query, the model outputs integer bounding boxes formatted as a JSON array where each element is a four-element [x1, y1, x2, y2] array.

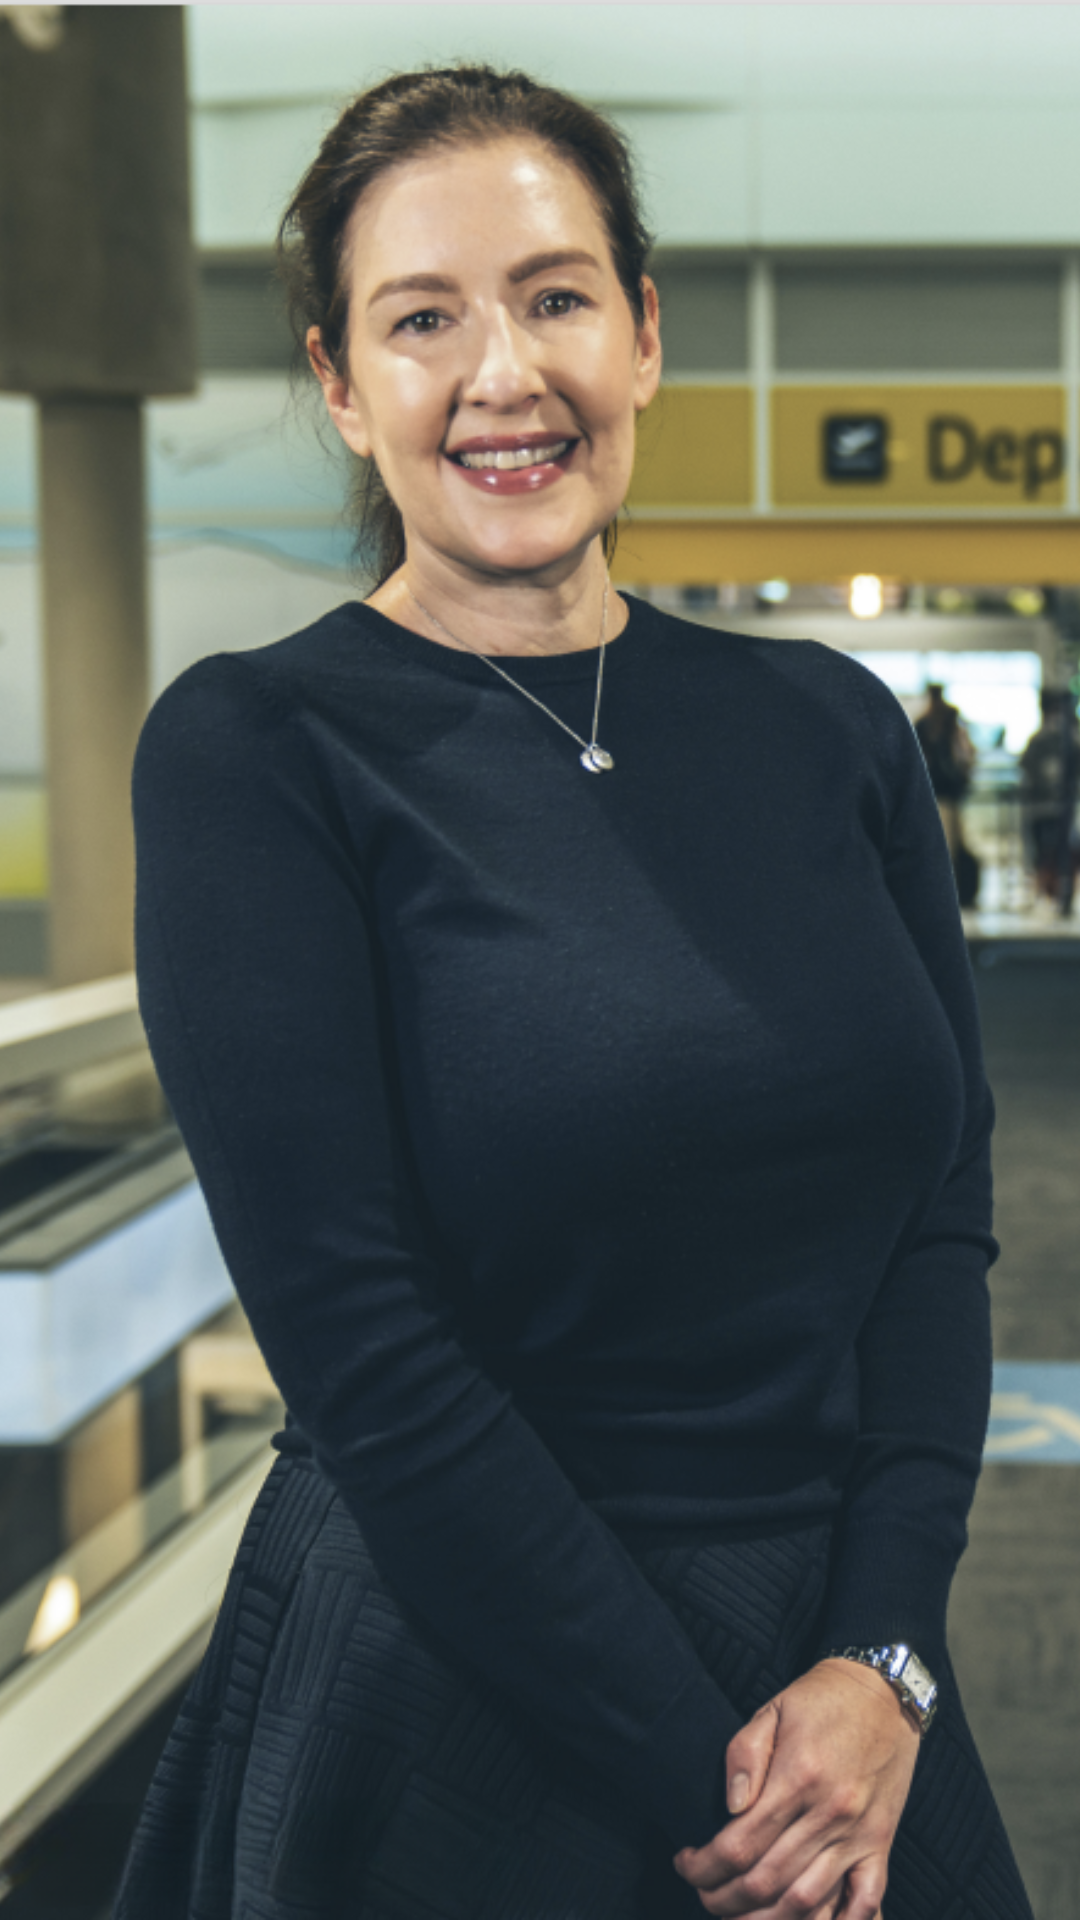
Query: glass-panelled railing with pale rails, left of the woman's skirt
[[0, 973, 282, 1862]]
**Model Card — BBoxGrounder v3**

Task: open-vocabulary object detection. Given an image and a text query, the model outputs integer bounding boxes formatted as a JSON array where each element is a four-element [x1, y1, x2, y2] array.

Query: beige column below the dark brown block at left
[[38, 396, 148, 987]]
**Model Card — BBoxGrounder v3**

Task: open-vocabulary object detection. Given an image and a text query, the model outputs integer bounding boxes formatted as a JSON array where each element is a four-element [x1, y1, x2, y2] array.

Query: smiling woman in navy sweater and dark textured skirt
[[117, 67, 1028, 1920]]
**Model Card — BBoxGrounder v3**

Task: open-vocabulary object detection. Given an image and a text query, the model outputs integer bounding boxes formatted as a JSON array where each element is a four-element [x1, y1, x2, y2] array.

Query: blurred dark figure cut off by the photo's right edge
[[1020, 687, 1080, 914]]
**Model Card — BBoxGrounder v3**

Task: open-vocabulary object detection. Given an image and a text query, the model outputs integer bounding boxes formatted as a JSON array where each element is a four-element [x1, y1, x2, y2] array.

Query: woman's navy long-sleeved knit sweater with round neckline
[[135, 601, 995, 1845]]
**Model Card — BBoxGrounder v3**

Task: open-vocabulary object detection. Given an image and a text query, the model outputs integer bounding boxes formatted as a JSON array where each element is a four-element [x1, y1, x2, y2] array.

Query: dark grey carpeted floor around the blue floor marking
[[951, 952, 1080, 1920]]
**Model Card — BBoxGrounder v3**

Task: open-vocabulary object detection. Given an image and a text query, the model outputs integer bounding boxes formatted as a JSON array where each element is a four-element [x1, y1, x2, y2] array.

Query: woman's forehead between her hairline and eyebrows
[[340, 138, 611, 286]]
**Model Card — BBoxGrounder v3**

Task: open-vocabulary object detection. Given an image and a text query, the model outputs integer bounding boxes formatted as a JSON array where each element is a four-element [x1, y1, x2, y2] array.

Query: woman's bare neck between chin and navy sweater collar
[[369, 541, 626, 655]]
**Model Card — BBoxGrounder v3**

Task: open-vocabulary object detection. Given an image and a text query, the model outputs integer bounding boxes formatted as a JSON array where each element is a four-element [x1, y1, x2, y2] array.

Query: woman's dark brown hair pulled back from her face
[[277, 65, 651, 586]]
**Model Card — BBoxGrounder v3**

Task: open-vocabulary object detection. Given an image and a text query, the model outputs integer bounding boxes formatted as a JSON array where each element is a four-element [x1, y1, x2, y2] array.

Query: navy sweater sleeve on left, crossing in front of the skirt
[[133, 655, 740, 1845]]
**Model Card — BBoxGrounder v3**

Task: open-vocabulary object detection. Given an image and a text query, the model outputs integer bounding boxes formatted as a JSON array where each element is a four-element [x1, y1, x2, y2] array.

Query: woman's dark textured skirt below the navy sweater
[[113, 1455, 1030, 1920]]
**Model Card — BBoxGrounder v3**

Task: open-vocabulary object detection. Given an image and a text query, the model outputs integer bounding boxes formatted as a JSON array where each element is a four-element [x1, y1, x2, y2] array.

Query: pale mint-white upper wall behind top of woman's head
[[188, 0, 1080, 248]]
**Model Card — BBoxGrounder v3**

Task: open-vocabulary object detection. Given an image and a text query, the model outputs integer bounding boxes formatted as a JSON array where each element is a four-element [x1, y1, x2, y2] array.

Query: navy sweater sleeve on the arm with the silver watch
[[817, 674, 997, 1665]]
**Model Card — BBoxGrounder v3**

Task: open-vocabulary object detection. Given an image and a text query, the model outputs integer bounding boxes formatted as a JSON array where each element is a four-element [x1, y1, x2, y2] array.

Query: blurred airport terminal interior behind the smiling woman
[[0, 11, 1080, 1920]]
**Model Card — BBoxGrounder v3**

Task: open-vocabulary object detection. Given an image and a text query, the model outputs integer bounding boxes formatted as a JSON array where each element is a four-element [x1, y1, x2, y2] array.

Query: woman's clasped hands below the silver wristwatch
[[675, 1659, 919, 1920]]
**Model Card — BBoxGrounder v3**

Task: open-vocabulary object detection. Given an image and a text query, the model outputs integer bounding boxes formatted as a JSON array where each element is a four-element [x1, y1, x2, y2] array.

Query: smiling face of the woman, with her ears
[[307, 138, 659, 578]]
